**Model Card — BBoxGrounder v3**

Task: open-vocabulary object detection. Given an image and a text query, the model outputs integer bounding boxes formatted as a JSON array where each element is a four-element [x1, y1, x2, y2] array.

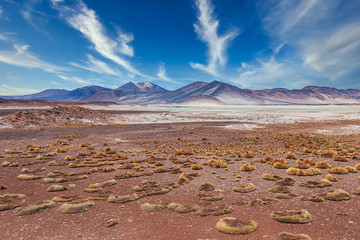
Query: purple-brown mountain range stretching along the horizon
[[3, 81, 360, 105]]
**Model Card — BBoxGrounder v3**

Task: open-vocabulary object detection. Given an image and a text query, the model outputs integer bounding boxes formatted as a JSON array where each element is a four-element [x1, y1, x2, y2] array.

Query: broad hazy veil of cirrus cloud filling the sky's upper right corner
[[262, 0, 360, 81]]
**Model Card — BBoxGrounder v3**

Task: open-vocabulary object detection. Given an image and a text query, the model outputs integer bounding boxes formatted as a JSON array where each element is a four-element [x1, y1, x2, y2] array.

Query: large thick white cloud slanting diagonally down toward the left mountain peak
[[53, 0, 145, 77]]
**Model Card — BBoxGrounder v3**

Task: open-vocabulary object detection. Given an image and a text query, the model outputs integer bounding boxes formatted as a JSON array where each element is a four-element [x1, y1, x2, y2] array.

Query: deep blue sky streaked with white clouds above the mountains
[[0, 0, 360, 95]]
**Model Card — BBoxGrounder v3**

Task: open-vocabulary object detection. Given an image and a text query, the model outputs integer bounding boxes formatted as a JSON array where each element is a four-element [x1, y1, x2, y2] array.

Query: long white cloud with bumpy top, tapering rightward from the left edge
[[0, 44, 68, 73]]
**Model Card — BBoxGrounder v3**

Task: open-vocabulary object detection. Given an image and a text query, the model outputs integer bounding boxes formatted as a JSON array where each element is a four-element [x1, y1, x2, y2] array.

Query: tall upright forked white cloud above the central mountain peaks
[[190, 0, 239, 76]]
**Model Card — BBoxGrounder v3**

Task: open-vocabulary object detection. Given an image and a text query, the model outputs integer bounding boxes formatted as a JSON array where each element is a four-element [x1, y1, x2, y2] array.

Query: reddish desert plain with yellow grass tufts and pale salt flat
[[0, 103, 360, 240]]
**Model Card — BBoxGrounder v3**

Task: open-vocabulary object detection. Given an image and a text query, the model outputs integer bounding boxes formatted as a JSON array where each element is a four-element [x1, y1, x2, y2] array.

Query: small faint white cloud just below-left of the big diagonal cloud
[[70, 54, 122, 76]]
